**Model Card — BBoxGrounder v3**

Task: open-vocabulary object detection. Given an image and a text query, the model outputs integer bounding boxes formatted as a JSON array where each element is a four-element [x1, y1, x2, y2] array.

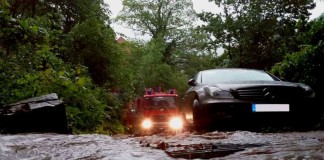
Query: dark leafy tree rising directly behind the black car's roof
[[200, 0, 315, 69]]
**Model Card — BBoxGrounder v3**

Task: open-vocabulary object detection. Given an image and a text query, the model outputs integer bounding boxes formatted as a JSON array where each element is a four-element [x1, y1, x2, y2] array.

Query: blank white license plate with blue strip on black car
[[252, 104, 289, 112]]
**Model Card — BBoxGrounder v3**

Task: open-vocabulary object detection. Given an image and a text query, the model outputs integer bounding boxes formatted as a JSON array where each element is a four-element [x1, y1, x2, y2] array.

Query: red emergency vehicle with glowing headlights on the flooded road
[[126, 88, 185, 134]]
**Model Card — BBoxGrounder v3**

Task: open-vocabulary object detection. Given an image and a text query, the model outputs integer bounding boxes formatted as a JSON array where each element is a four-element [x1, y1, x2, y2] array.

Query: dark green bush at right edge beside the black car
[[271, 16, 324, 99]]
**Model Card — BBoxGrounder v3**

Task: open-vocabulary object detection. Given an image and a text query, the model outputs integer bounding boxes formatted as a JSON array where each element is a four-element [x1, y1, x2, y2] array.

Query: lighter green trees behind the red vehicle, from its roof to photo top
[[117, 0, 213, 96]]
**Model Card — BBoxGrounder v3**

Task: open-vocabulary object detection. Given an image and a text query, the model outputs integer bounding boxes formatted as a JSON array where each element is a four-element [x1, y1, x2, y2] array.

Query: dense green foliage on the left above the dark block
[[0, 1, 123, 134]]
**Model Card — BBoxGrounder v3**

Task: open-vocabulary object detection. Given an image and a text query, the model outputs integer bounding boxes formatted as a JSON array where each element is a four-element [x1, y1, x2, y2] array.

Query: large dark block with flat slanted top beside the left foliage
[[0, 93, 69, 134]]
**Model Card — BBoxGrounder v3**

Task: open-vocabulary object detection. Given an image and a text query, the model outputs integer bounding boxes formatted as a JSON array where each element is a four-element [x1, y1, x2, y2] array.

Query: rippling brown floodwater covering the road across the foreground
[[0, 131, 324, 160]]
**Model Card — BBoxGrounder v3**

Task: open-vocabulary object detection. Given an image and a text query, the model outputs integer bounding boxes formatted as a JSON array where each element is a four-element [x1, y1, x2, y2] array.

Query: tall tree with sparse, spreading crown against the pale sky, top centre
[[116, 0, 196, 64]]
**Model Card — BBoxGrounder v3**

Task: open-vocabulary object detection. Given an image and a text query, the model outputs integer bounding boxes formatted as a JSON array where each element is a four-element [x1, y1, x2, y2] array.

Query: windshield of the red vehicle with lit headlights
[[141, 97, 176, 109]]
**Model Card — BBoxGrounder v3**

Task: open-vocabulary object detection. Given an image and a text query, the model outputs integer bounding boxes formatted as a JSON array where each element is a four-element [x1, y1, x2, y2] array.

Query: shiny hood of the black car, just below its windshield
[[210, 81, 300, 90]]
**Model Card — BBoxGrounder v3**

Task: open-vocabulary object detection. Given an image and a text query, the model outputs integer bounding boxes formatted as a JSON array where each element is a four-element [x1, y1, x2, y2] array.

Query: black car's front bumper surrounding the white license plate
[[196, 99, 319, 120]]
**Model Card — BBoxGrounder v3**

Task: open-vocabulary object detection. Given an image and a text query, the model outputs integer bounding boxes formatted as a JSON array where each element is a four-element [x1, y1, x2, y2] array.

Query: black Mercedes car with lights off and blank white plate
[[183, 68, 315, 128]]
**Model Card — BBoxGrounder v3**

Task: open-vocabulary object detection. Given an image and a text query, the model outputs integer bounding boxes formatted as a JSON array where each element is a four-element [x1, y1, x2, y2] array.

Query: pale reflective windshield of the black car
[[201, 69, 275, 84]]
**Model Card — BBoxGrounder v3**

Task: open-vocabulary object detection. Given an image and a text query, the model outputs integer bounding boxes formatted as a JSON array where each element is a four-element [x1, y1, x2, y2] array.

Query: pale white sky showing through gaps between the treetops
[[104, 0, 324, 39]]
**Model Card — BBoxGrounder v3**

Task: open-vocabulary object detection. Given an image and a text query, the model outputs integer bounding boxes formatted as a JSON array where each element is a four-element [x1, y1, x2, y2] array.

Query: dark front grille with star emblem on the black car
[[235, 86, 302, 101]]
